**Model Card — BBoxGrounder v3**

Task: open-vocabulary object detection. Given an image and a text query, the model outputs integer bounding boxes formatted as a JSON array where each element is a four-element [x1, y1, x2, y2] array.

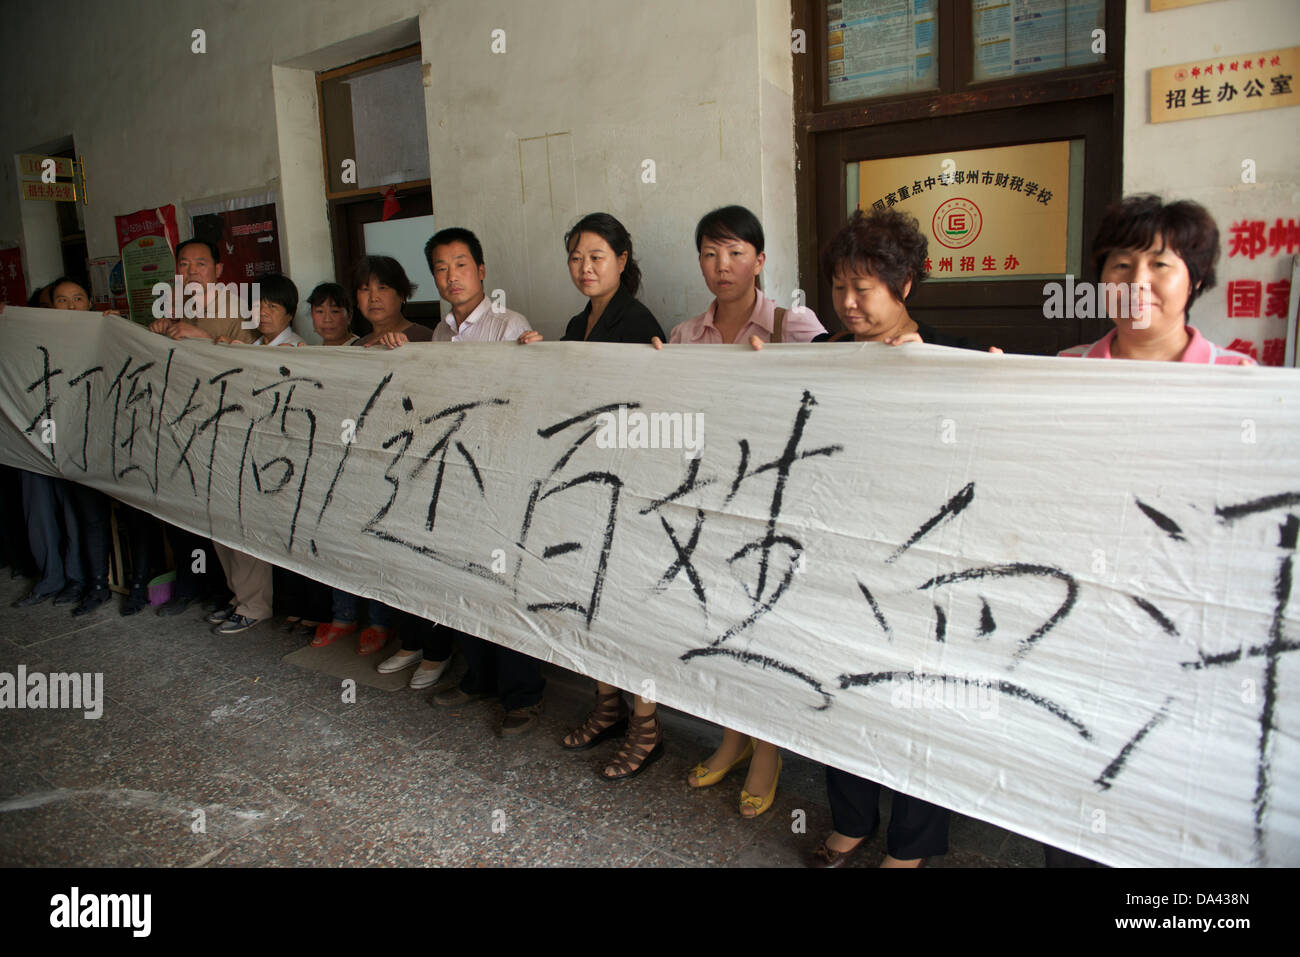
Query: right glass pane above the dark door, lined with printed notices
[[970, 0, 1106, 83]]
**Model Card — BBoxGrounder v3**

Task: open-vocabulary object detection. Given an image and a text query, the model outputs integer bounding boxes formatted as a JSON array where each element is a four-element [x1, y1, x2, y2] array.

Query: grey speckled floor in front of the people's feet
[[0, 571, 1043, 867]]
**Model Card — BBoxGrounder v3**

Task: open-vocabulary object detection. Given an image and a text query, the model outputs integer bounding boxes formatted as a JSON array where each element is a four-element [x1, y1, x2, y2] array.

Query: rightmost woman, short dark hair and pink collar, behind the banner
[[1060, 195, 1255, 365]]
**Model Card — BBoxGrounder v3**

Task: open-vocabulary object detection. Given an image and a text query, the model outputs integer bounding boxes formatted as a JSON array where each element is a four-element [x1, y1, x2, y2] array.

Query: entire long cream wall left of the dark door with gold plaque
[[0, 0, 798, 335]]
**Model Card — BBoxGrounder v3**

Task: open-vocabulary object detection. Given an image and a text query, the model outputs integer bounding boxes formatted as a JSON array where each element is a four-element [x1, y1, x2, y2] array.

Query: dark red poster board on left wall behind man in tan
[[185, 190, 283, 282]]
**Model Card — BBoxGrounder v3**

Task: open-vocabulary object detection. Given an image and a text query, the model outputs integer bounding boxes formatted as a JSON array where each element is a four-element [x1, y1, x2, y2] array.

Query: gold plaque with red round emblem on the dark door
[[849, 140, 1082, 280]]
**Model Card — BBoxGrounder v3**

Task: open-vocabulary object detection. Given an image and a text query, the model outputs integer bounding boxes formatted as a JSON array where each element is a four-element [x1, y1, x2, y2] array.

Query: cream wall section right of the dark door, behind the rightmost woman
[[1118, 0, 1300, 361]]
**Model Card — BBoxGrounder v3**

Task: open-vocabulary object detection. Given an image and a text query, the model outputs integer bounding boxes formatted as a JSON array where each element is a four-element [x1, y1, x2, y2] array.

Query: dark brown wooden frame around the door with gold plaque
[[792, 0, 1125, 351]]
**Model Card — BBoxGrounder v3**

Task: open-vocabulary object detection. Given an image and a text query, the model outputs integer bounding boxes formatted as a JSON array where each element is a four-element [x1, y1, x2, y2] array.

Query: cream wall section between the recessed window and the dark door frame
[[420, 0, 797, 337]]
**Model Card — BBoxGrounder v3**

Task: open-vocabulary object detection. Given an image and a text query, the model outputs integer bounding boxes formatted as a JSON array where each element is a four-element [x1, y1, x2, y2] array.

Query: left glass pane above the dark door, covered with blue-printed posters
[[826, 0, 939, 103]]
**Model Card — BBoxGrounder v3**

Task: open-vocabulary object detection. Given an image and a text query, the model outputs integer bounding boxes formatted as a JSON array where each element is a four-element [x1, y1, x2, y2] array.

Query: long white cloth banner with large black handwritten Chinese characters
[[0, 308, 1300, 865]]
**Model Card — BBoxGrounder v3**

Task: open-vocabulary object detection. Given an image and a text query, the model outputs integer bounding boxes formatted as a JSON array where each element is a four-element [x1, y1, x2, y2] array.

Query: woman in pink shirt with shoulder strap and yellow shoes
[[654, 205, 826, 818]]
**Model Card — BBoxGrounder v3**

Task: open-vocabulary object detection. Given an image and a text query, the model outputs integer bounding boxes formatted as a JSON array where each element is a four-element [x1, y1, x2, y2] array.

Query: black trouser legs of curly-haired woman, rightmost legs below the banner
[[826, 767, 948, 861]]
